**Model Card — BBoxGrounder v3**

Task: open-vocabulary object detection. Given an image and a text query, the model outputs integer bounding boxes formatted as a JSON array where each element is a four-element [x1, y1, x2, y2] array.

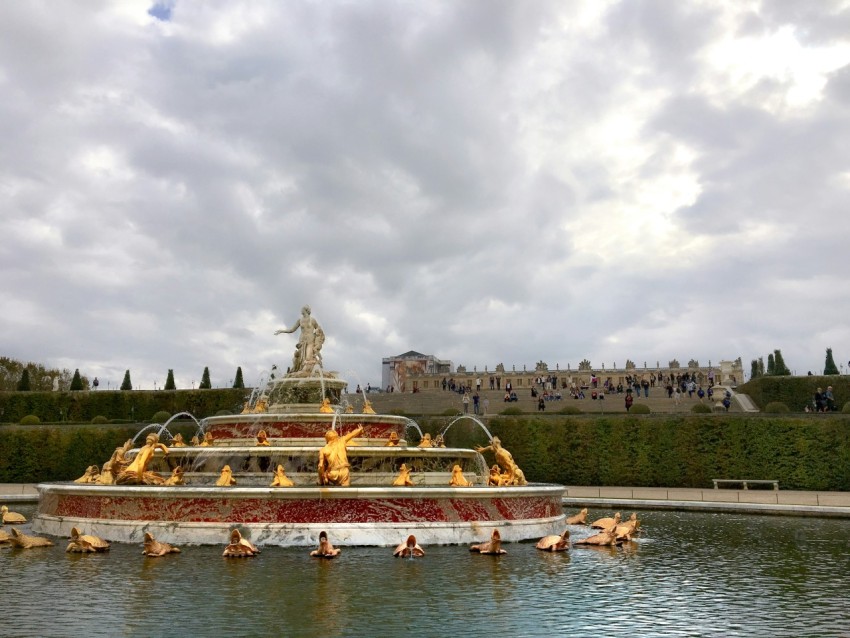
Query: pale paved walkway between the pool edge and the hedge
[[6, 483, 850, 518]]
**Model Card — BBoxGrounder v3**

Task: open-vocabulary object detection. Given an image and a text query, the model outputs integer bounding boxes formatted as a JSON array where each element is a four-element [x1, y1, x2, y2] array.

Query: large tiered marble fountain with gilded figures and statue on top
[[33, 307, 564, 546]]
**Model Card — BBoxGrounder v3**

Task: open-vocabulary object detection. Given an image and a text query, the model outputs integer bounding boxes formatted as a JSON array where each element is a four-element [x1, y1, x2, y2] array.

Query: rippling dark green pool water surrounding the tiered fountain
[[0, 506, 850, 638]]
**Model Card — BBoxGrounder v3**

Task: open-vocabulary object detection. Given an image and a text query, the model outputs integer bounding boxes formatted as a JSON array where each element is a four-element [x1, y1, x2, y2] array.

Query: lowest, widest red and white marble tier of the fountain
[[33, 483, 565, 546]]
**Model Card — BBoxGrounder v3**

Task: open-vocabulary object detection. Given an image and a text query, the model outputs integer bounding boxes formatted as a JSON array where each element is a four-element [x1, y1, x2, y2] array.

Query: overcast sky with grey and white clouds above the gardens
[[0, 0, 850, 389]]
